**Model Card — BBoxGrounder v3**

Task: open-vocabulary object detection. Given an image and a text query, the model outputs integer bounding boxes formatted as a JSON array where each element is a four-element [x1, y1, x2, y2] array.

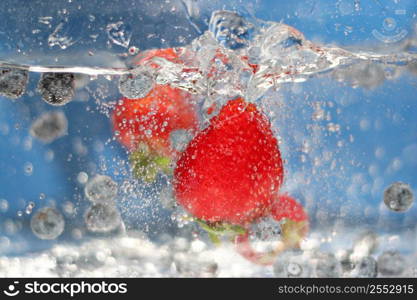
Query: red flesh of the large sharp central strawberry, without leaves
[[174, 98, 283, 225]]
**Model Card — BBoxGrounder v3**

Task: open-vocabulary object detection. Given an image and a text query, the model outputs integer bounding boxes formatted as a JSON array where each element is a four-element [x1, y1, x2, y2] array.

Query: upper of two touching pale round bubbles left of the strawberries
[[82, 175, 118, 203]]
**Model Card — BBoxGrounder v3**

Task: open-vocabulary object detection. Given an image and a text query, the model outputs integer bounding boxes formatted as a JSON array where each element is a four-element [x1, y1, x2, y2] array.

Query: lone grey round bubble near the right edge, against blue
[[384, 182, 414, 212]]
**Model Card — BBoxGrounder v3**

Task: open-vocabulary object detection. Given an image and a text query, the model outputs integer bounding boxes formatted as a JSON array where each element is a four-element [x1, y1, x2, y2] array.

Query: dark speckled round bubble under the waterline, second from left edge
[[38, 72, 75, 106]]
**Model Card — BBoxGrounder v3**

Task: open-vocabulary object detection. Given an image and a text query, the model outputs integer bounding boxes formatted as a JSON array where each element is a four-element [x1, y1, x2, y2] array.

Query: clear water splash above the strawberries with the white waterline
[[0, 11, 417, 101]]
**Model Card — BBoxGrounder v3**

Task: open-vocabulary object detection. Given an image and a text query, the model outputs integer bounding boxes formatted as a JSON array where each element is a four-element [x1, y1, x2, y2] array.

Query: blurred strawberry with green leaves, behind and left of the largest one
[[112, 48, 198, 182]]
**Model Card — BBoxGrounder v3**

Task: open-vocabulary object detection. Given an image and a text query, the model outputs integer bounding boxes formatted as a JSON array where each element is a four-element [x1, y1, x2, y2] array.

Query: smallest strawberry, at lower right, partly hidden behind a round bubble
[[235, 195, 309, 265]]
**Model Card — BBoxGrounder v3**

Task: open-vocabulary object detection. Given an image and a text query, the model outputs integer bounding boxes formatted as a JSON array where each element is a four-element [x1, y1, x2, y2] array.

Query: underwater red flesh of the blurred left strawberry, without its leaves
[[109, 85, 197, 156]]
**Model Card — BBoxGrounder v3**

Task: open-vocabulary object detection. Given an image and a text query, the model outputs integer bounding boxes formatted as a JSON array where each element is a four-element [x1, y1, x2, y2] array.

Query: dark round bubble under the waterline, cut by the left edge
[[0, 68, 29, 99]]
